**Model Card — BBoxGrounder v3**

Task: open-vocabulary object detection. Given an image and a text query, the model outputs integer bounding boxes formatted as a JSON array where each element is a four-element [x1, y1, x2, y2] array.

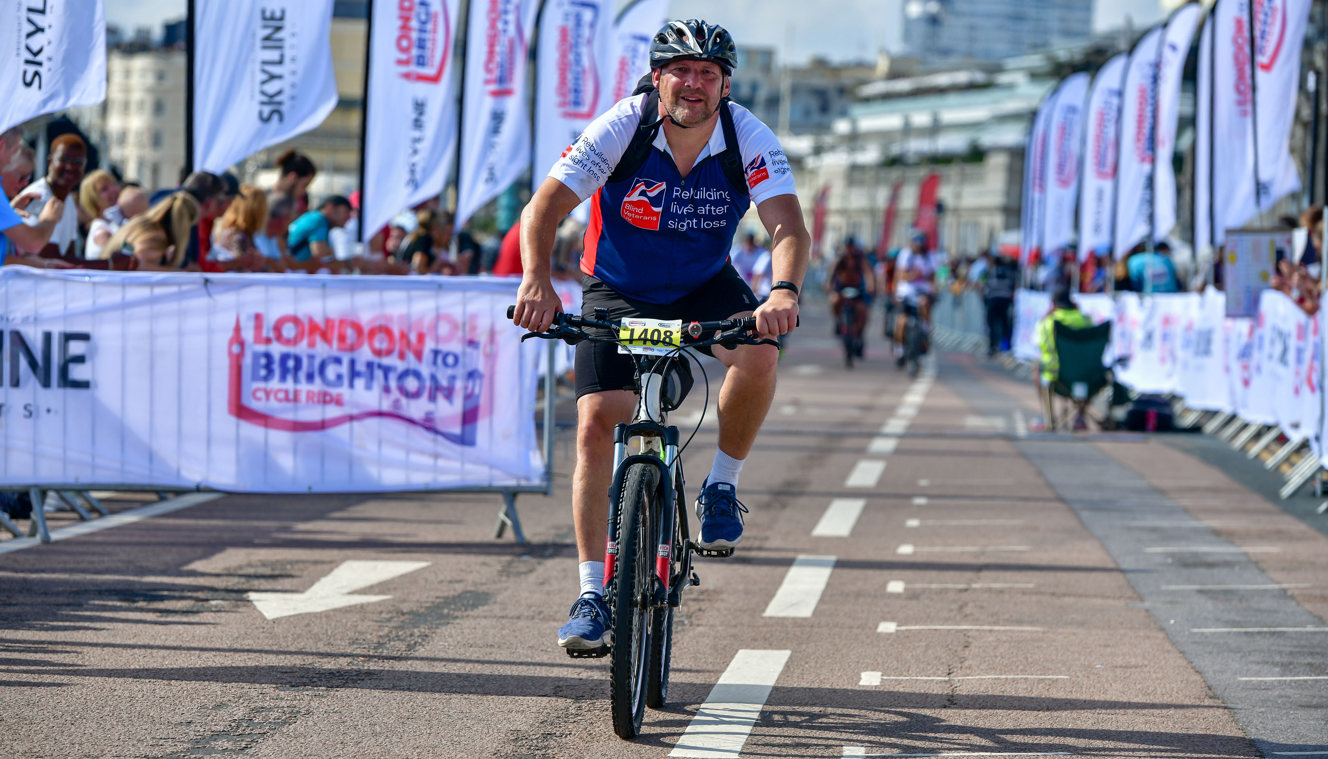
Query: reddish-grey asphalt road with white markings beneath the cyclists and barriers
[[0, 305, 1328, 759]]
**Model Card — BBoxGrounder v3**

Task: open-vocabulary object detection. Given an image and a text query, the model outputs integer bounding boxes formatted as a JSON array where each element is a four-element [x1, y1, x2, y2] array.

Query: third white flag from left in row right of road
[[1078, 53, 1129, 261]]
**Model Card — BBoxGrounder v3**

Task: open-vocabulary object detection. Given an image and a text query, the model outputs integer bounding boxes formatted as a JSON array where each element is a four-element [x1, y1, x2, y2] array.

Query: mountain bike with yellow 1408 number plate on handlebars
[[507, 308, 778, 739]]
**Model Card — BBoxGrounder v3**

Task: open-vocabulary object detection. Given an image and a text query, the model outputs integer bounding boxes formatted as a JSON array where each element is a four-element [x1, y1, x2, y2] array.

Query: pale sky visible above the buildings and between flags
[[105, 0, 1162, 64]]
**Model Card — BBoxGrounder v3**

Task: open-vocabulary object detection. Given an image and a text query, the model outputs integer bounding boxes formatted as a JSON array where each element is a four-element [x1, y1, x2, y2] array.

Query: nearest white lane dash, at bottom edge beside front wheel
[[669, 649, 791, 759]]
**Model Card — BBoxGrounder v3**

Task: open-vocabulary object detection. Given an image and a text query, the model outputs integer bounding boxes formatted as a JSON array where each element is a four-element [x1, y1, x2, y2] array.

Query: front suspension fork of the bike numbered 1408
[[604, 422, 685, 606]]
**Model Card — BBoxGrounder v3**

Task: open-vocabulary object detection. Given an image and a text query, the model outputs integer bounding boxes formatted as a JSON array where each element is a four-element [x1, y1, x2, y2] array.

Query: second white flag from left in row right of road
[[1042, 73, 1089, 253]]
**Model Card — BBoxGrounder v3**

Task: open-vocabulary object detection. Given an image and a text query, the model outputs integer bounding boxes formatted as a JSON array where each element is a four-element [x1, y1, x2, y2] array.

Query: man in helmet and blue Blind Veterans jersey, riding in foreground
[[513, 20, 810, 650]]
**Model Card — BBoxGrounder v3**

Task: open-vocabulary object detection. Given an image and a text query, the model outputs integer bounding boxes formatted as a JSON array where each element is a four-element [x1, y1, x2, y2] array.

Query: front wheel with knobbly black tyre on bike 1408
[[608, 463, 660, 740]]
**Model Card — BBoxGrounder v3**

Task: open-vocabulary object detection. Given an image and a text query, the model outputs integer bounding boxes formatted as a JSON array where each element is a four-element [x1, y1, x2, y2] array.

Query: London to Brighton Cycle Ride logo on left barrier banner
[[227, 313, 494, 446]]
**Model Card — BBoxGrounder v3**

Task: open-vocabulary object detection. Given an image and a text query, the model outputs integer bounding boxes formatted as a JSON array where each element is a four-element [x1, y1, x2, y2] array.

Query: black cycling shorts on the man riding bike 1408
[[575, 264, 760, 398]]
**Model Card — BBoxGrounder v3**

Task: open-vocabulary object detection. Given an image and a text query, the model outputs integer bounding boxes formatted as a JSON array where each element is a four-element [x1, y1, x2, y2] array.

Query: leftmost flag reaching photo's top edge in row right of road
[[1153, 3, 1203, 240]]
